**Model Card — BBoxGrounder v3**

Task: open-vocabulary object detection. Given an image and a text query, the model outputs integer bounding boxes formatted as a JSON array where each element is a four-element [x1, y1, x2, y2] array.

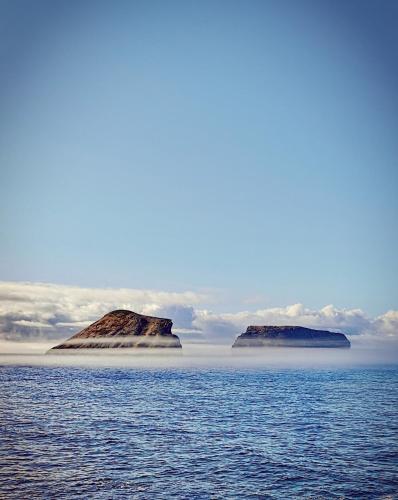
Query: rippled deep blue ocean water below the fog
[[0, 365, 398, 499]]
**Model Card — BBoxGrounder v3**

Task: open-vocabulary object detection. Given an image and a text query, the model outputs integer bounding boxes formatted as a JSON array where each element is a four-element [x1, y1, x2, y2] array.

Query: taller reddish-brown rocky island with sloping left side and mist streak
[[49, 309, 181, 352]]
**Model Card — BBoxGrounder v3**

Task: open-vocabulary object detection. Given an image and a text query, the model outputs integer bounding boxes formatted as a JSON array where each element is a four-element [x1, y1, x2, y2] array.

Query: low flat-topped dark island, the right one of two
[[232, 326, 351, 347]]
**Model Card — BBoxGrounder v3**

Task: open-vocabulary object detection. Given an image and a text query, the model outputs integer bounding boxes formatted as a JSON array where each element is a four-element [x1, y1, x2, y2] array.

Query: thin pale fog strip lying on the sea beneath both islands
[[0, 341, 398, 369]]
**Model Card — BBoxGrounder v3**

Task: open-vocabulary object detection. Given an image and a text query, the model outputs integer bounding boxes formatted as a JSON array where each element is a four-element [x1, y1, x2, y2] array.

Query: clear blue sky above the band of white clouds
[[0, 0, 398, 344]]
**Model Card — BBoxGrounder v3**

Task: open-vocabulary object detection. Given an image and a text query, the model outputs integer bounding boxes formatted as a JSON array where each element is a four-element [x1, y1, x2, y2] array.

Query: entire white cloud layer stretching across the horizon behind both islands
[[0, 282, 398, 344]]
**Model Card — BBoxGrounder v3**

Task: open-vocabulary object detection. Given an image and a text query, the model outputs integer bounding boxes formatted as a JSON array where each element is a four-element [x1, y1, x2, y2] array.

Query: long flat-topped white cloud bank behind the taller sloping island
[[0, 282, 206, 339]]
